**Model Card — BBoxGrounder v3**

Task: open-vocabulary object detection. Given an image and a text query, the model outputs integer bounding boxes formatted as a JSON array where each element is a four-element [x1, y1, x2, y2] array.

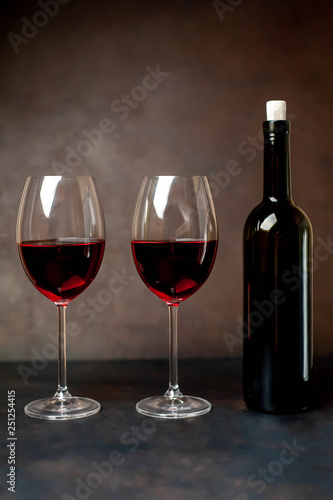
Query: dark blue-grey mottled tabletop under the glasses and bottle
[[0, 358, 333, 500]]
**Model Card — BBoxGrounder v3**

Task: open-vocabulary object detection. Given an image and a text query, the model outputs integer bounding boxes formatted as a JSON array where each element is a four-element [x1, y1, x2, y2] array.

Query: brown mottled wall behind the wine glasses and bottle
[[0, 0, 333, 361]]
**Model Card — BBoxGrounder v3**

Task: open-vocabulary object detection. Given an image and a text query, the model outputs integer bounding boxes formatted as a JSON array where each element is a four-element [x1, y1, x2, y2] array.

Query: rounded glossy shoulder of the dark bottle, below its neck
[[244, 200, 312, 237]]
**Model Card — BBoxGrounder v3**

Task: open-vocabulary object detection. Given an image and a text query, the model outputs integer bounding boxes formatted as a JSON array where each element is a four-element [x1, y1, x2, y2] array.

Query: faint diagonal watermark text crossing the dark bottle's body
[[223, 234, 333, 354]]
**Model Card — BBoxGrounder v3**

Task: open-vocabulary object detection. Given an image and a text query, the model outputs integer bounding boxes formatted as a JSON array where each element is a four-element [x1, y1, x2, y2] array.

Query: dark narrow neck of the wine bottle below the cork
[[263, 120, 291, 202]]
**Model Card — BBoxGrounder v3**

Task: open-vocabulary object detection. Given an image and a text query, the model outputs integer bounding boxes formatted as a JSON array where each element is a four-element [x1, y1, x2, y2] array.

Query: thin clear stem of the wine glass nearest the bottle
[[165, 304, 182, 398]]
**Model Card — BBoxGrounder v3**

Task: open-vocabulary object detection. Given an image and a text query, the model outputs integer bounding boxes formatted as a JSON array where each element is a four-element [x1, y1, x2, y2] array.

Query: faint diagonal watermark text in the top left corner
[[7, 0, 70, 54]]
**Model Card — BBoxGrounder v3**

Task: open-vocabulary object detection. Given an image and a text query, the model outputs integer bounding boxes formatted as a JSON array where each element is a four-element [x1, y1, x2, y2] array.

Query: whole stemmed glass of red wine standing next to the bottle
[[132, 176, 218, 418]]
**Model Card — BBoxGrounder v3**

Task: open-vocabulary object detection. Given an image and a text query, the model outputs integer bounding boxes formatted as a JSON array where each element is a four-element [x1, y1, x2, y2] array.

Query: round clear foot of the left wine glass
[[24, 396, 101, 420]]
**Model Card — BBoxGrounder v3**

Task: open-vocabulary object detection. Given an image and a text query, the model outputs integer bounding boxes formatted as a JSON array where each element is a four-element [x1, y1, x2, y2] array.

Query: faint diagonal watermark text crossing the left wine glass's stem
[[16, 268, 134, 386]]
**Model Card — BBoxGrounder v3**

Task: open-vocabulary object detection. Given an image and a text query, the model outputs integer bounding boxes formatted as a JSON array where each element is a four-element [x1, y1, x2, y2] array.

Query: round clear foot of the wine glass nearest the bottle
[[136, 396, 212, 419]]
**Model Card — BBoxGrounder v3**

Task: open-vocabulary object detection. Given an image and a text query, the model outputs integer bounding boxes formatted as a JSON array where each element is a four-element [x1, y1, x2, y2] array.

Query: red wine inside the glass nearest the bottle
[[132, 240, 217, 302]]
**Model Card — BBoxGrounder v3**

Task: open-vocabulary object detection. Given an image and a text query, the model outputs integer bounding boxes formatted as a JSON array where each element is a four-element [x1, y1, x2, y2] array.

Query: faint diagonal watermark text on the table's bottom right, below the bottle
[[235, 438, 307, 500]]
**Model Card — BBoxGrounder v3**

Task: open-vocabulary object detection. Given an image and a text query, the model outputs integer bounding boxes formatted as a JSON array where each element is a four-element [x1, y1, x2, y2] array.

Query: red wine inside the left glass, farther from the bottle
[[18, 238, 105, 302]]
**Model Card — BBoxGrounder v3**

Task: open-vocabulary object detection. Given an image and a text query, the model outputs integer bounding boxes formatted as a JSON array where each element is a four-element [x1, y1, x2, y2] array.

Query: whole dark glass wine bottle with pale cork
[[243, 101, 313, 413]]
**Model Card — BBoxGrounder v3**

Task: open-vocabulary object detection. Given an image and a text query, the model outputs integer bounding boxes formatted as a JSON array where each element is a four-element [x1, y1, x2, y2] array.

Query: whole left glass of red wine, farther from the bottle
[[16, 176, 105, 420]]
